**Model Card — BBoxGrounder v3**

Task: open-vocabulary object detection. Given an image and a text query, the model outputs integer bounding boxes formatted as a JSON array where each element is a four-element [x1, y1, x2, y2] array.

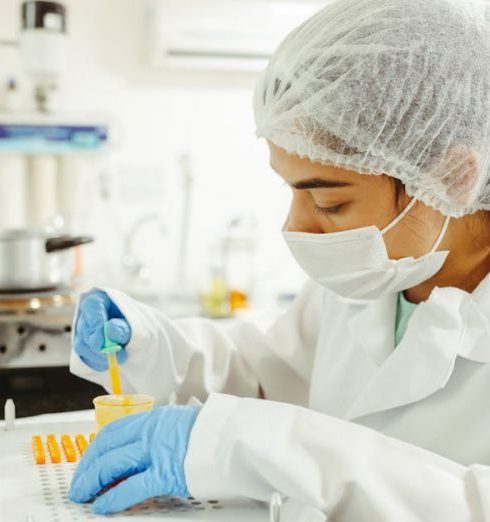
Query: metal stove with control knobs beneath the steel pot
[[0, 287, 105, 417]]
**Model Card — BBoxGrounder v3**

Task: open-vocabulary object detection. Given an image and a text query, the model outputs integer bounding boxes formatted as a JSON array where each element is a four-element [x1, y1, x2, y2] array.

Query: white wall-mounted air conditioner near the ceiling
[[148, 0, 327, 70]]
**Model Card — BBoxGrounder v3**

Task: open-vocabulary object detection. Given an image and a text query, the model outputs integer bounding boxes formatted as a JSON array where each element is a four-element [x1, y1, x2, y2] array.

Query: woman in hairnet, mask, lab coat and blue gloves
[[69, 0, 490, 522]]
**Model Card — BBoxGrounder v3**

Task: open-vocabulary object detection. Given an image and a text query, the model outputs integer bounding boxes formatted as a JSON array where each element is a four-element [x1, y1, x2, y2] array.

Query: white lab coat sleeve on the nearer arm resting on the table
[[185, 394, 490, 522]]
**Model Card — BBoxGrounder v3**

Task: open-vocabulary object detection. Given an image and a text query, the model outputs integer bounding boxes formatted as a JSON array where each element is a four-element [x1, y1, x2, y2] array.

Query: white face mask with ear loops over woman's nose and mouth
[[283, 199, 450, 299]]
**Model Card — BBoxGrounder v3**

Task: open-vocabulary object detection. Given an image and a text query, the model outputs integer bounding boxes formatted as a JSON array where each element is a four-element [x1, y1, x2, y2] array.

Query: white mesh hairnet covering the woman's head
[[254, 0, 490, 216]]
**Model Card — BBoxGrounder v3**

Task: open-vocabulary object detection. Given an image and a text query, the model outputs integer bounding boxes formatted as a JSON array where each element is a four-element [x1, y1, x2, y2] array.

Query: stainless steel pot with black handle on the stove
[[0, 230, 93, 292]]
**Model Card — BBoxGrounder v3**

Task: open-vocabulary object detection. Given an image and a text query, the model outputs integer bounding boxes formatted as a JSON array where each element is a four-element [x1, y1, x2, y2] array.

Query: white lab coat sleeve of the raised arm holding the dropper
[[70, 280, 321, 404]]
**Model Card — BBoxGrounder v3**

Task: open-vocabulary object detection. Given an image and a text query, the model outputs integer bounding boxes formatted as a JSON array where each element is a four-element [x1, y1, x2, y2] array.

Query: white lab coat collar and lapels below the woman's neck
[[346, 276, 490, 419]]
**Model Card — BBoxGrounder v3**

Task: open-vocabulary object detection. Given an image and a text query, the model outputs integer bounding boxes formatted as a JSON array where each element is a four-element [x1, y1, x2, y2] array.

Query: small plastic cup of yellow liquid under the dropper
[[93, 394, 155, 431]]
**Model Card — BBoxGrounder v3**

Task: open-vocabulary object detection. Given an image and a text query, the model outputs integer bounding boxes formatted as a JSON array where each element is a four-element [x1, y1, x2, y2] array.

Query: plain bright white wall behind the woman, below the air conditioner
[[0, 0, 301, 304]]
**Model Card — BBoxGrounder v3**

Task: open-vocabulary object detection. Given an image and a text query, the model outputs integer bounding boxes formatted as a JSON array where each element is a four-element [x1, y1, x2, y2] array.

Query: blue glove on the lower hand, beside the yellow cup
[[68, 406, 200, 515]]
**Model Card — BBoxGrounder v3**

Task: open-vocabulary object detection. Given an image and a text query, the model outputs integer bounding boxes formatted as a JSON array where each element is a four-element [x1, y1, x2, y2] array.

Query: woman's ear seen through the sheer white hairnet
[[438, 145, 481, 207]]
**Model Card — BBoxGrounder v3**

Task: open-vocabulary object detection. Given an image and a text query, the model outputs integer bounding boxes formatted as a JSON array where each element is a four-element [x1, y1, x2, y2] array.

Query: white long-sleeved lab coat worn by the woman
[[71, 276, 490, 522]]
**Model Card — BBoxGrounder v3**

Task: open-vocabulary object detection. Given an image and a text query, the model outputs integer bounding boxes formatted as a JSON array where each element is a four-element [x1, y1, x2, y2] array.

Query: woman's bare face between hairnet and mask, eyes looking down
[[268, 142, 444, 259]]
